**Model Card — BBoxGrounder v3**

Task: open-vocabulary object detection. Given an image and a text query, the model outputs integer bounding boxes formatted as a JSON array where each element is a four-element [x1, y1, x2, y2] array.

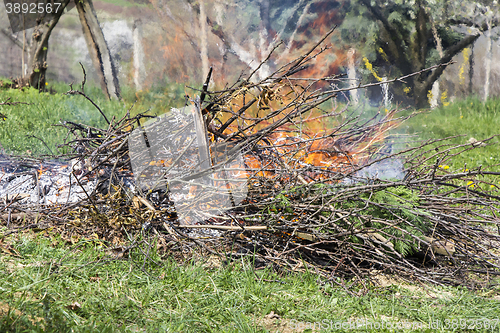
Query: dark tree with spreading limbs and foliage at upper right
[[341, 0, 498, 107]]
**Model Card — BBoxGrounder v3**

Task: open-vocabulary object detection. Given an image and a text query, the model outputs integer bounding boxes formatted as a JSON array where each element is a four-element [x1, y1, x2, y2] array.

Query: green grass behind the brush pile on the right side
[[353, 97, 500, 191]]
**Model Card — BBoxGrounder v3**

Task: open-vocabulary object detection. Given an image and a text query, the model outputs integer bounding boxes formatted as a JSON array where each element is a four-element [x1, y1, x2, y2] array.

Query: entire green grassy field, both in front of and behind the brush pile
[[0, 84, 500, 332]]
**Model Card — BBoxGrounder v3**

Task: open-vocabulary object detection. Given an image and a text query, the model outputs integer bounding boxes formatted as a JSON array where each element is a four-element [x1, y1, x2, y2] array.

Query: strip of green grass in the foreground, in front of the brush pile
[[0, 232, 500, 332]]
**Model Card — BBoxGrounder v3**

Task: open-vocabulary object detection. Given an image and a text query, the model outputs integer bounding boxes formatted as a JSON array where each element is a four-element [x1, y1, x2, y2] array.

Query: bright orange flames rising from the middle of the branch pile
[[212, 82, 399, 182]]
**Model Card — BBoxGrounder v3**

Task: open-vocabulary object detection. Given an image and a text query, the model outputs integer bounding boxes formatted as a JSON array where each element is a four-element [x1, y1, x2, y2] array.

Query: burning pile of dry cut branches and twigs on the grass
[[3, 29, 500, 286]]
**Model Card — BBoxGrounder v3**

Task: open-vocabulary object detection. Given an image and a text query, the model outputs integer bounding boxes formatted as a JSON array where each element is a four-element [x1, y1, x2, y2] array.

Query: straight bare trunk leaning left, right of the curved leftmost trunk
[[75, 0, 120, 99]]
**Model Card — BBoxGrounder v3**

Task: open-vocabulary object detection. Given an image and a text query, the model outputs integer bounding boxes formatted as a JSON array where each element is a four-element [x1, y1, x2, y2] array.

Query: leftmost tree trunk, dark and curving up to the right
[[28, 0, 70, 90]]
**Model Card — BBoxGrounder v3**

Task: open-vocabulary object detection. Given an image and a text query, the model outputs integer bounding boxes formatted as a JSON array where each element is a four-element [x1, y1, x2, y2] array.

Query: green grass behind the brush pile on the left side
[[0, 82, 188, 156]]
